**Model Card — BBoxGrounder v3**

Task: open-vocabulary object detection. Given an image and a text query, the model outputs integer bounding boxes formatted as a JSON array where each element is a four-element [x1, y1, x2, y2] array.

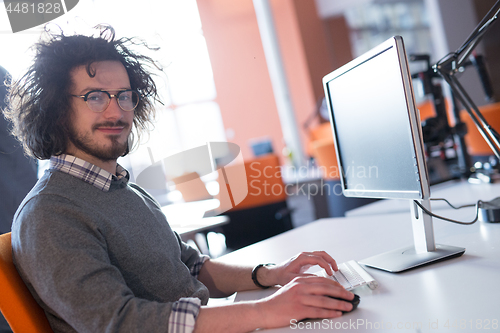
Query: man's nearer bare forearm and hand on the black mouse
[[195, 275, 354, 333]]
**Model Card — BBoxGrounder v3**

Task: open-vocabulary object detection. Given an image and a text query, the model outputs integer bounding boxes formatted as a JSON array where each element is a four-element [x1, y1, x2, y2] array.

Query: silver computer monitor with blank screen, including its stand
[[323, 36, 465, 272]]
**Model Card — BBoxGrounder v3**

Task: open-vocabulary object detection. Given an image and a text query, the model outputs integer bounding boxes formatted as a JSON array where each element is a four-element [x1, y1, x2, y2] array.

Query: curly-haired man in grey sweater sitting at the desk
[[6, 27, 354, 332]]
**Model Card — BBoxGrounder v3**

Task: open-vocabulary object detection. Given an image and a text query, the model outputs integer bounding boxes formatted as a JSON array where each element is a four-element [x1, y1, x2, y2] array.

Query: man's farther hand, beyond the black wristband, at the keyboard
[[257, 251, 338, 286]]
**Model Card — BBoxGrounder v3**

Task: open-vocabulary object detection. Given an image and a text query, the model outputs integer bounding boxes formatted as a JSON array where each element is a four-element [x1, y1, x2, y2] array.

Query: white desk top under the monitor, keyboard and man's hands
[[221, 180, 500, 333]]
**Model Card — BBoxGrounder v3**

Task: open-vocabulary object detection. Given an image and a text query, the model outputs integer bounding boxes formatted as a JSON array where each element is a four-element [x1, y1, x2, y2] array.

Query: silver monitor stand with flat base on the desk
[[359, 199, 465, 273]]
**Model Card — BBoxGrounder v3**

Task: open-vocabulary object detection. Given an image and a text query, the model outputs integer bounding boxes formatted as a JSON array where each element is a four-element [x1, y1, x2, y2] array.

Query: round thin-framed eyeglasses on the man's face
[[71, 89, 141, 112]]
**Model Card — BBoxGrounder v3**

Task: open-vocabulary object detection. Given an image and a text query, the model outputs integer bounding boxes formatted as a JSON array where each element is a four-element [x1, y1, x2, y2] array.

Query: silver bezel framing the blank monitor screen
[[323, 36, 430, 199]]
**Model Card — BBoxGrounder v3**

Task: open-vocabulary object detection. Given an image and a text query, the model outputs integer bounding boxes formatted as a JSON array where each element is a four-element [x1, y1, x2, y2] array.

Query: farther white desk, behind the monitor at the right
[[346, 181, 500, 217]]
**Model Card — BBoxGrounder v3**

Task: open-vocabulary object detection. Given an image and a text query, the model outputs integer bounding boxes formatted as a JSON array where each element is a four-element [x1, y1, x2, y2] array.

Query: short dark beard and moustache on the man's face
[[68, 121, 130, 162]]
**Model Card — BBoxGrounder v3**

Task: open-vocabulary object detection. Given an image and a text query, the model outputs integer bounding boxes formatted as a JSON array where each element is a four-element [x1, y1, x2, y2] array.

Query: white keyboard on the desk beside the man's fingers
[[324, 260, 378, 290]]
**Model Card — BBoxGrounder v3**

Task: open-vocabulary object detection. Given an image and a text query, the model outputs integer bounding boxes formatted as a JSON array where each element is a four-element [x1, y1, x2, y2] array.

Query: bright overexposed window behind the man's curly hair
[[0, 0, 225, 201]]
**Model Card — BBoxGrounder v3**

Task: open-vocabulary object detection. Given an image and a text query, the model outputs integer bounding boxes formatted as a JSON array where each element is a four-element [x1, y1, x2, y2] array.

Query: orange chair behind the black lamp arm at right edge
[[460, 102, 500, 156]]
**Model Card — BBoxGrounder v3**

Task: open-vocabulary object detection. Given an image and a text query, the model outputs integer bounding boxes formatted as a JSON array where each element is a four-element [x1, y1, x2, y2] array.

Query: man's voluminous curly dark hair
[[4, 25, 161, 159]]
